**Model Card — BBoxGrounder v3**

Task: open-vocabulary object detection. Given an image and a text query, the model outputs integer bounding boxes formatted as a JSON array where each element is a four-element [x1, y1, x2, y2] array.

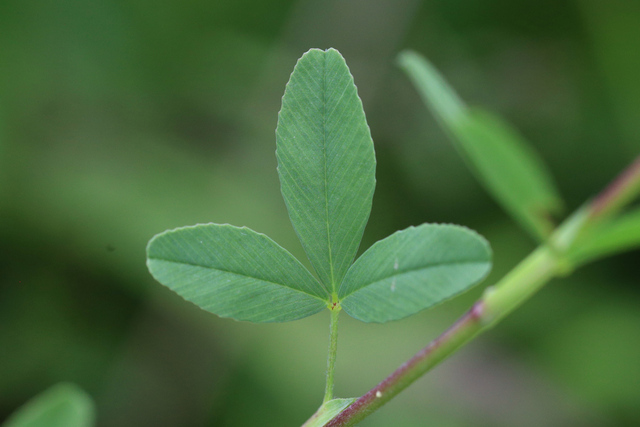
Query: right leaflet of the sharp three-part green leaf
[[339, 224, 491, 322]]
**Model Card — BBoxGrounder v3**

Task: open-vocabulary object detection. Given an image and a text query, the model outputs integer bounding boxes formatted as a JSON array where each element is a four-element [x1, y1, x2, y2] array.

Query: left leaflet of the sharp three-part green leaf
[[147, 224, 330, 322]]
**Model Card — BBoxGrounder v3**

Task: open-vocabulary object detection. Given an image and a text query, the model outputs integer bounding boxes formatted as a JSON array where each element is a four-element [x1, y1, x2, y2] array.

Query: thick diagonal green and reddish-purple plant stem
[[324, 157, 640, 427]]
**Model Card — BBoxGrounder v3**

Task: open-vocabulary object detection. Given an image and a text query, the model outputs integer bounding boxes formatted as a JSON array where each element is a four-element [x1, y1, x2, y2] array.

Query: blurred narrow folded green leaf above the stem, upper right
[[398, 51, 562, 240]]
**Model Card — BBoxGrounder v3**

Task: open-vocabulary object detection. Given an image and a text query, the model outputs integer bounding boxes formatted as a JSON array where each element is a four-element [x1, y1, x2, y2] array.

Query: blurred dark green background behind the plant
[[0, 0, 640, 427]]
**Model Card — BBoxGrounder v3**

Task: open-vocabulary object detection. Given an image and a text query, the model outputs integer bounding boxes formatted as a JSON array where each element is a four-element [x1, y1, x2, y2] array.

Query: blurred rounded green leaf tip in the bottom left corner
[[3, 383, 95, 427]]
